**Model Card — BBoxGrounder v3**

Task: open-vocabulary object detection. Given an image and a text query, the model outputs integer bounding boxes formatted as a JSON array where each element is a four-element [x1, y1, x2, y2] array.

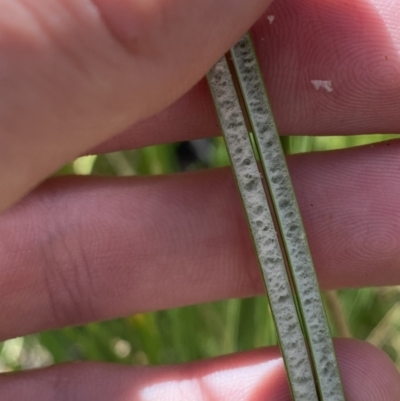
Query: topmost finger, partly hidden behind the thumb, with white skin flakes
[[90, 0, 400, 152]]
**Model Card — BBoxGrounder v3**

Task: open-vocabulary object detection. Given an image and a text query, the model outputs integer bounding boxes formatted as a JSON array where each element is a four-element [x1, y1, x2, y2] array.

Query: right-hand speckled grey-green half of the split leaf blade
[[231, 34, 345, 401]]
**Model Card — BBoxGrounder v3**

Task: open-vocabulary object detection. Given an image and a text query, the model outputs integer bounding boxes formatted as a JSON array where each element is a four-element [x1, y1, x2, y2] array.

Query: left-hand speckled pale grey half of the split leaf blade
[[208, 58, 318, 401]]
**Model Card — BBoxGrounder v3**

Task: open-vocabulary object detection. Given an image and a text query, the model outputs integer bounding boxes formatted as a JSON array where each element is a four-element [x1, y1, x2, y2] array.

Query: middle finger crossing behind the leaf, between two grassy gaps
[[0, 142, 400, 339]]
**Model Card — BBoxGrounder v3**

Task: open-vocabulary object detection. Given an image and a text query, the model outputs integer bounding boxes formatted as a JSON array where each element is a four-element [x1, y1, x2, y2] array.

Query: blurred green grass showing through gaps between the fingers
[[0, 135, 400, 372]]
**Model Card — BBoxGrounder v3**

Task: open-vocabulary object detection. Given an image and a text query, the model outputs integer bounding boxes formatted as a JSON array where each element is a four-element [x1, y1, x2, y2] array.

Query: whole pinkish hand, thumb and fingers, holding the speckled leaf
[[0, 0, 400, 401]]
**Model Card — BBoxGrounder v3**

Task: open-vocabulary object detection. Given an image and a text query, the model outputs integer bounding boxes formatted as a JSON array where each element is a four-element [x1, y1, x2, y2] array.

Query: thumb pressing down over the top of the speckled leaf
[[0, 0, 270, 211]]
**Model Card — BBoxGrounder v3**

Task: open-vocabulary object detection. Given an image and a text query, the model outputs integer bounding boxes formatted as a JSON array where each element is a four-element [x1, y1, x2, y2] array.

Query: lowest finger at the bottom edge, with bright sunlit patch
[[0, 340, 400, 401]]
